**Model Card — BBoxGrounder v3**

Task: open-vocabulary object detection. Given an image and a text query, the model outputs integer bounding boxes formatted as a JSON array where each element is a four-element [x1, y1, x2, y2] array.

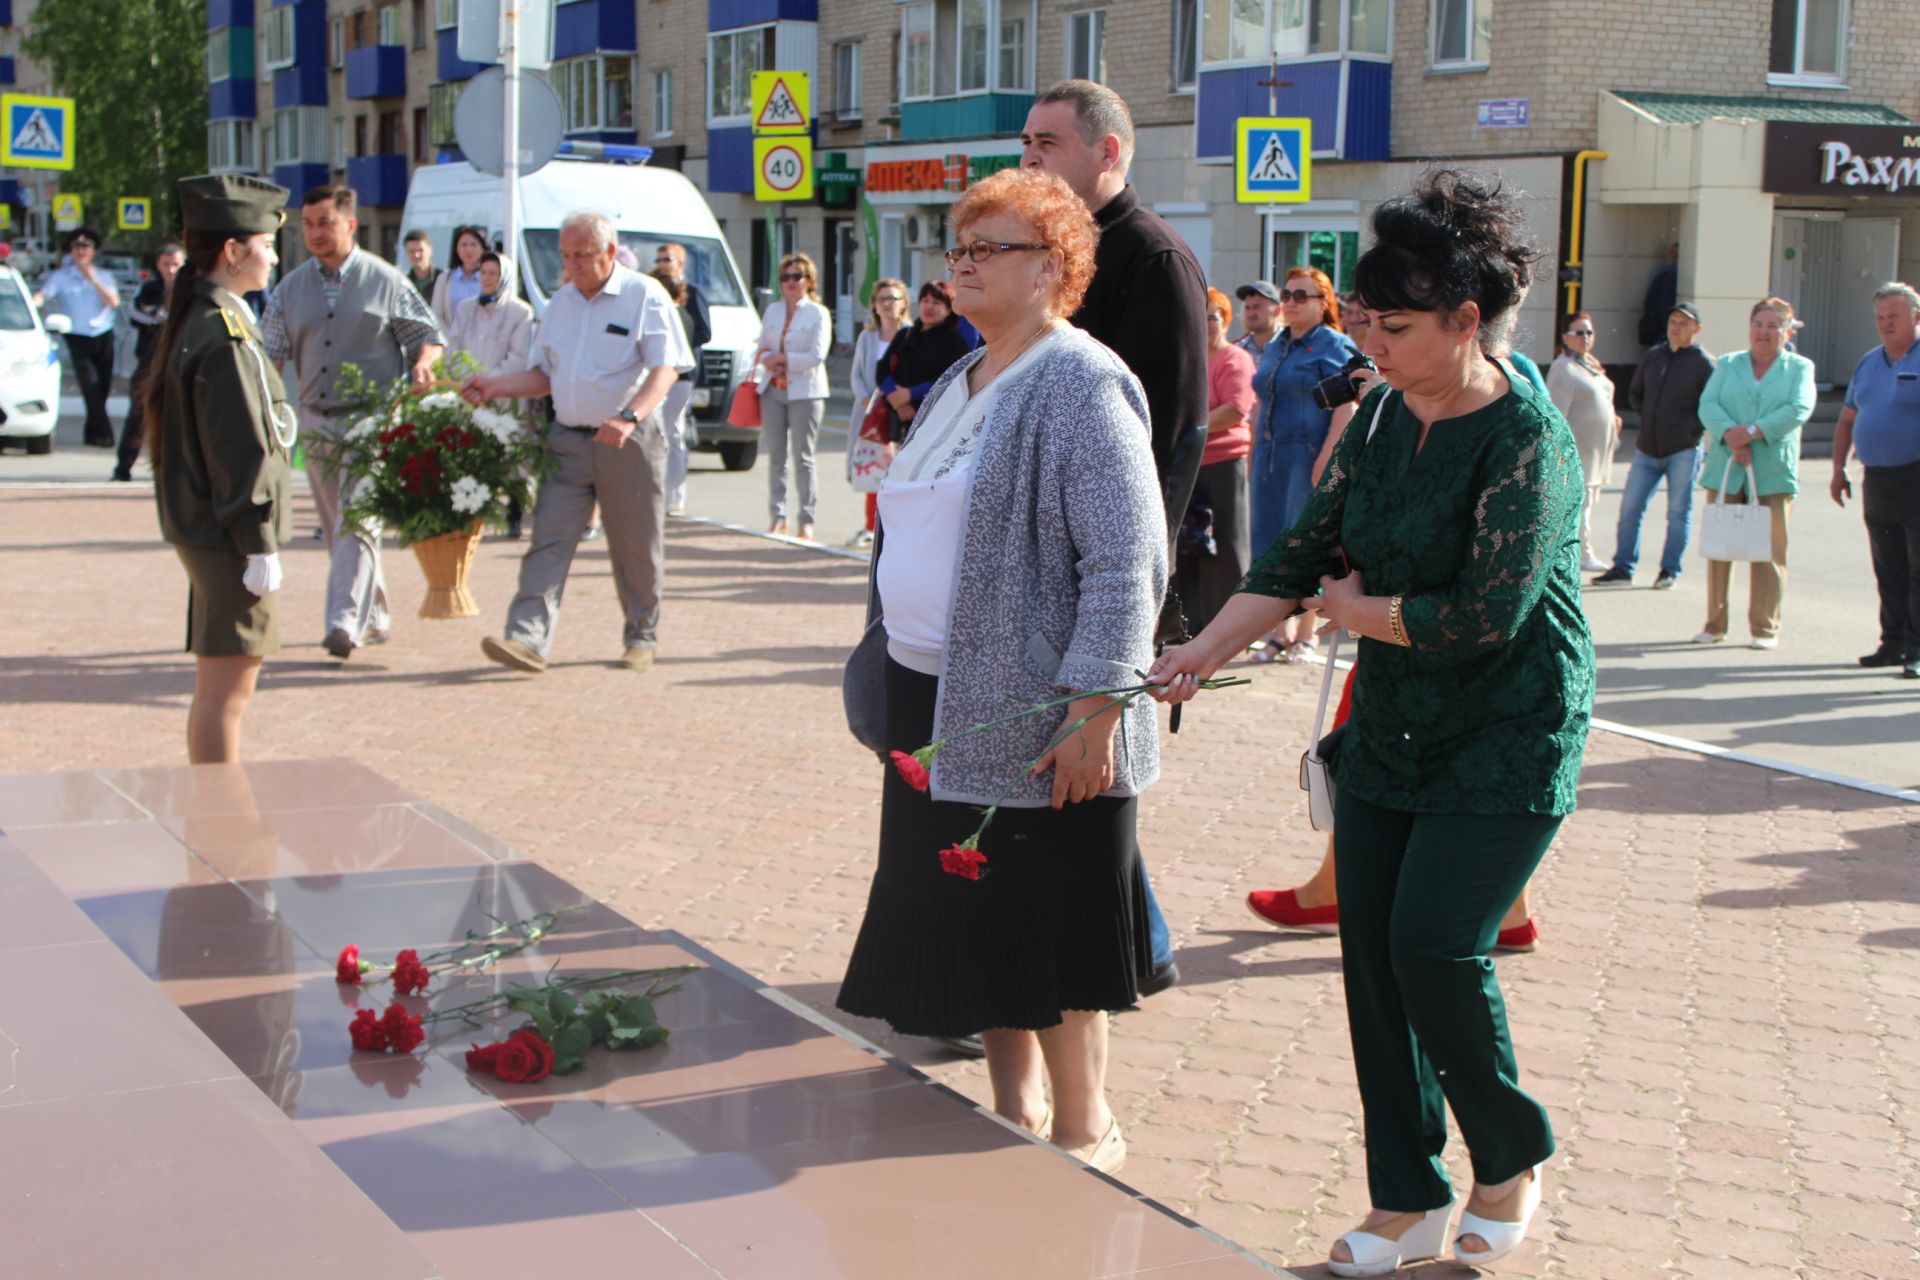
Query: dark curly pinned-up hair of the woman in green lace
[[1354, 169, 1540, 349]]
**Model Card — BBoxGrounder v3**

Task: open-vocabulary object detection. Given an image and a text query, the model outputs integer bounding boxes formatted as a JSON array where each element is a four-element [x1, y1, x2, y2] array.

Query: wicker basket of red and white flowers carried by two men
[[323, 351, 549, 618]]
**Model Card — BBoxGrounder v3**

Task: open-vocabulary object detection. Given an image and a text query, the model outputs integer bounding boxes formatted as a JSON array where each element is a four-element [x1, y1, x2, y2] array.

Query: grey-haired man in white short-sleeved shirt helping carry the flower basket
[[465, 213, 693, 672]]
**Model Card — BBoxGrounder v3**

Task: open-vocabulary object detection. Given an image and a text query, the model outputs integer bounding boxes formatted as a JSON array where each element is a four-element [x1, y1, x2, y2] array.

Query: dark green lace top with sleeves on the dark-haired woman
[[1240, 364, 1594, 814]]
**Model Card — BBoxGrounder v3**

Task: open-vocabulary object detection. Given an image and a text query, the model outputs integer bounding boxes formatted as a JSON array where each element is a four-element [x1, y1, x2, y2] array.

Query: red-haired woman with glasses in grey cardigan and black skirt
[[839, 169, 1167, 1171]]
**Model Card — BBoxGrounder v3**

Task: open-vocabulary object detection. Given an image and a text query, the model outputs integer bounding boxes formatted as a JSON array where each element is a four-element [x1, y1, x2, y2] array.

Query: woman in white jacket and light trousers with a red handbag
[[756, 253, 833, 541]]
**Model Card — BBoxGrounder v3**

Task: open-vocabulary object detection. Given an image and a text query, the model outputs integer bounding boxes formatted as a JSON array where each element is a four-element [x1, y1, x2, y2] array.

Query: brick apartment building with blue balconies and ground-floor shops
[[207, 0, 1920, 376]]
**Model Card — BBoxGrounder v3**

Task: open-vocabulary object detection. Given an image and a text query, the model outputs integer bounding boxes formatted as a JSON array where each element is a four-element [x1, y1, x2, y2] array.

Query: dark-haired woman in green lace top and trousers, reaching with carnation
[[1152, 171, 1594, 1276]]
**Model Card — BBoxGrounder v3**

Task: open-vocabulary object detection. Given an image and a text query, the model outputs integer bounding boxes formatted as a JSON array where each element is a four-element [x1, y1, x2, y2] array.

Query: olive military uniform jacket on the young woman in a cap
[[154, 280, 296, 555]]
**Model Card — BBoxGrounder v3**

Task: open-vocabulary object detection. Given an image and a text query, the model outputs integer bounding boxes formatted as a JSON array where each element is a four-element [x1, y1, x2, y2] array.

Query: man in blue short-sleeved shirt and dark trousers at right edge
[[1828, 280, 1920, 679]]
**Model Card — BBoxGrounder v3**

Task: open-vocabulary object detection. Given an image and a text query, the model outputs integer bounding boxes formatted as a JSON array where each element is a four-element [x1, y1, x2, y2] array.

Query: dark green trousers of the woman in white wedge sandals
[[1334, 789, 1561, 1213]]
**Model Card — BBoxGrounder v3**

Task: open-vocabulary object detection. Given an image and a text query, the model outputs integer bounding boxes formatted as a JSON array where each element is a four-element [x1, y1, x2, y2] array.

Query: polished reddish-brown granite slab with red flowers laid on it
[[0, 760, 1275, 1280]]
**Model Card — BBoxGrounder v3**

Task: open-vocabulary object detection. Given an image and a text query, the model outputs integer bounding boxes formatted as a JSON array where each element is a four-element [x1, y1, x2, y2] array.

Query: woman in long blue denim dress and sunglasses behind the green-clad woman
[[1248, 267, 1359, 662]]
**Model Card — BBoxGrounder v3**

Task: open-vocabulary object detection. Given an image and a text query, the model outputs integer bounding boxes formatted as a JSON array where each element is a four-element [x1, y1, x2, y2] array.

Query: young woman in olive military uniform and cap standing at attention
[[146, 175, 296, 764]]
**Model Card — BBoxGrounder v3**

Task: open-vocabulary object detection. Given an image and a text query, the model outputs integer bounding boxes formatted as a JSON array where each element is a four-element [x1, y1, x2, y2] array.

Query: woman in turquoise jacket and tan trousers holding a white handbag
[[1693, 297, 1814, 649]]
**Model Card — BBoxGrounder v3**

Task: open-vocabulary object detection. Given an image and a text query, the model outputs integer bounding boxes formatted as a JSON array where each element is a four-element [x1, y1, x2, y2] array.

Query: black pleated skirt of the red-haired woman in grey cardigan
[[837, 658, 1152, 1036]]
